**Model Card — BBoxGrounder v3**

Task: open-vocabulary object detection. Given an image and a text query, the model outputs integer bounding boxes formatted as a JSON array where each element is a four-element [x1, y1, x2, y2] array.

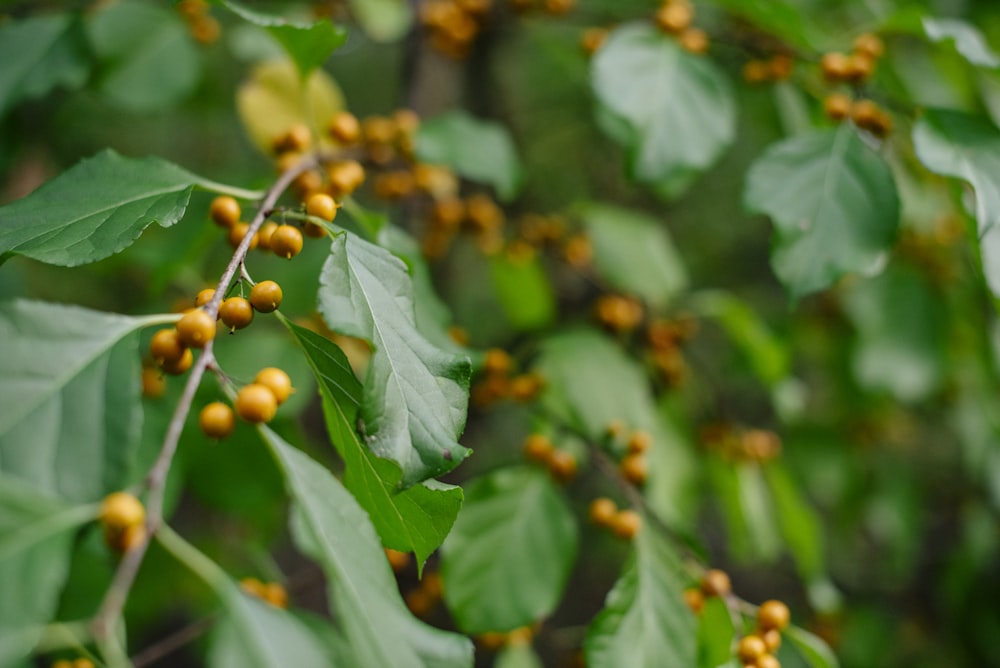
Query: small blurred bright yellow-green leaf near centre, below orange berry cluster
[[490, 254, 556, 331]]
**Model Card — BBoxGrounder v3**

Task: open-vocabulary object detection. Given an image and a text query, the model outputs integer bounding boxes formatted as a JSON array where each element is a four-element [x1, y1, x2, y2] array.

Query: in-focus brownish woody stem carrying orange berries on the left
[[92, 154, 315, 650]]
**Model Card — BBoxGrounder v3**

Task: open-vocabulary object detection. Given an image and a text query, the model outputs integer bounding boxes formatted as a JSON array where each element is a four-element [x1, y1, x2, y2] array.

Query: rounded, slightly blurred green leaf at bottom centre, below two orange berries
[[441, 467, 578, 633]]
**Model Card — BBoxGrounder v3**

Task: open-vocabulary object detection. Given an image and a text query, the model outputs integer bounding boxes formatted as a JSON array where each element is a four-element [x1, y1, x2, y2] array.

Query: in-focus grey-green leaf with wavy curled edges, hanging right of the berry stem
[[319, 232, 472, 487]]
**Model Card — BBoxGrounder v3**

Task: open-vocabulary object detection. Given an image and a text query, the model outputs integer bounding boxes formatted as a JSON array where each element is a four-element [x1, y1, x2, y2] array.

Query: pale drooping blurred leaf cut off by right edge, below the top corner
[[913, 109, 1000, 296]]
